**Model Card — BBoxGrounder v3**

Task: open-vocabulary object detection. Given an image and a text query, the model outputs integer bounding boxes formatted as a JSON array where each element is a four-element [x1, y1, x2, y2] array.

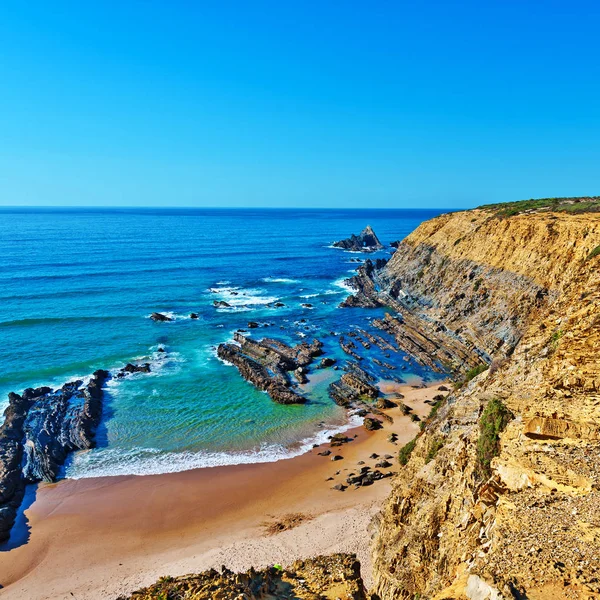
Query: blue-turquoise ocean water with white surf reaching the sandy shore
[[0, 209, 441, 477]]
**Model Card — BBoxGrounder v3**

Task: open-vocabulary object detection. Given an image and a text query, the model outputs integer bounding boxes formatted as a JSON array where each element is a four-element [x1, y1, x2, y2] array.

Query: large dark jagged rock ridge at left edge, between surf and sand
[[0, 370, 109, 541]]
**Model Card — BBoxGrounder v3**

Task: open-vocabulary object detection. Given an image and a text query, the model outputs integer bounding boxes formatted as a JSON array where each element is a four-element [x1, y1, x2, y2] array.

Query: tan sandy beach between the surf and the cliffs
[[0, 382, 441, 600]]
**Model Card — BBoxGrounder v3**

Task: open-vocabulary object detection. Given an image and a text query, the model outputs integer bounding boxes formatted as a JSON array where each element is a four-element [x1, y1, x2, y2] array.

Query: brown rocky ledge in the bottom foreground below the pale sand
[[119, 554, 367, 600]]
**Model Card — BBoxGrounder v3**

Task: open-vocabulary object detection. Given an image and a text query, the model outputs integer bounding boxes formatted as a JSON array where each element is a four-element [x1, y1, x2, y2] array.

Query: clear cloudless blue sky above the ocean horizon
[[0, 0, 600, 207]]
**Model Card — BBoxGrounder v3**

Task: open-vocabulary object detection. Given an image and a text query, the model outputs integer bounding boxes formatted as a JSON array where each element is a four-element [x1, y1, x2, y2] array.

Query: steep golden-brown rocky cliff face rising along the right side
[[370, 210, 600, 600]]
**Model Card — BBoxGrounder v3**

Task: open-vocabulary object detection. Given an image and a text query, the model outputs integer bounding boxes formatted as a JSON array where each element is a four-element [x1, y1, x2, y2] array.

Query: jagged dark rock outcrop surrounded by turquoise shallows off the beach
[[217, 333, 323, 404]]
